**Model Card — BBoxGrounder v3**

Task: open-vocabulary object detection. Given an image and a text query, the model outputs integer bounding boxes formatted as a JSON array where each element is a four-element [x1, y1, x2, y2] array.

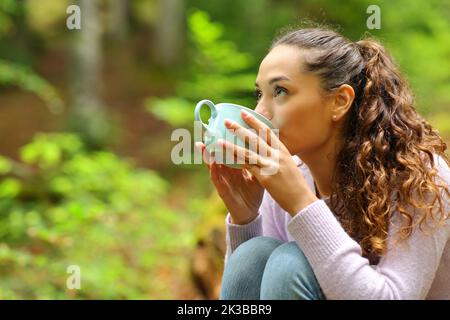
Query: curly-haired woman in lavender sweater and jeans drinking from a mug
[[197, 28, 450, 299]]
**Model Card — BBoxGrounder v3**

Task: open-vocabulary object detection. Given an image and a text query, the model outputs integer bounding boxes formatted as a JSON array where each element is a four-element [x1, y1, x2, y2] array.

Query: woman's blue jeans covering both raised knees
[[220, 237, 325, 300]]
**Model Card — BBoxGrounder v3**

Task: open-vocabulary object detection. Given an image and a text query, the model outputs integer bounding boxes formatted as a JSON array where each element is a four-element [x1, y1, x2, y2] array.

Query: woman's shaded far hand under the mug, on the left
[[196, 142, 264, 224]]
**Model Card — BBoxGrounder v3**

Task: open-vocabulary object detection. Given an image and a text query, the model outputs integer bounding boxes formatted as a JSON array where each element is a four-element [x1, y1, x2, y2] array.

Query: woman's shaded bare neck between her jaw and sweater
[[297, 139, 339, 198]]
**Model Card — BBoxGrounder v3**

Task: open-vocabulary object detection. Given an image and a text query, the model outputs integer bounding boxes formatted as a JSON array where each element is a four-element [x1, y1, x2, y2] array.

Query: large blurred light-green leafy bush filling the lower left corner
[[0, 134, 194, 299]]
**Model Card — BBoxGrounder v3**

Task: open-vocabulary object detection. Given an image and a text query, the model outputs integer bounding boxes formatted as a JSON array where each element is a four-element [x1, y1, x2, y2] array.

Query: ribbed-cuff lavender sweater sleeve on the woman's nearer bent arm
[[288, 156, 450, 299]]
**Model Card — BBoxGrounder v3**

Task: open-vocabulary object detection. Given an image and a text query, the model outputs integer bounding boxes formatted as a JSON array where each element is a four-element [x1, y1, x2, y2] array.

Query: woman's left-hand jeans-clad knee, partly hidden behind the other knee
[[220, 237, 283, 299]]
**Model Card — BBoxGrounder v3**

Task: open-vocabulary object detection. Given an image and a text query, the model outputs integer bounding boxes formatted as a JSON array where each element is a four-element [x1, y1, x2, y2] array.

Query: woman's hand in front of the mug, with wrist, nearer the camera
[[219, 112, 317, 216]]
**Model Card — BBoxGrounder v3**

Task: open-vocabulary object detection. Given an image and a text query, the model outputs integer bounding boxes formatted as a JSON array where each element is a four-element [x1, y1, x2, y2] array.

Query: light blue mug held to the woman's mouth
[[194, 100, 275, 169]]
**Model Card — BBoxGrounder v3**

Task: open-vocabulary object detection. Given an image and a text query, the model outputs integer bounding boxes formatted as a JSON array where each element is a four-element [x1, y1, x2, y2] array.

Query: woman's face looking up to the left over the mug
[[255, 45, 333, 154]]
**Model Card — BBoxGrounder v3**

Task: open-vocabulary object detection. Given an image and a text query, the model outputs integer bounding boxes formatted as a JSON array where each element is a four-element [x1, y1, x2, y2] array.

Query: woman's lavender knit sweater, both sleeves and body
[[225, 156, 450, 299]]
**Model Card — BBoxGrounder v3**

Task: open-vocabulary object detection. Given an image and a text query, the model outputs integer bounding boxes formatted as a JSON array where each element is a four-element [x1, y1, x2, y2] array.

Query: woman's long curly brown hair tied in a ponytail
[[270, 28, 450, 258]]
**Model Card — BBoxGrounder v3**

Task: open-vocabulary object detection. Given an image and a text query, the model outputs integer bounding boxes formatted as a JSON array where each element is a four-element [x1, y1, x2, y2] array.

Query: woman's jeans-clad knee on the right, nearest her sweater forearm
[[261, 242, 325, 300]]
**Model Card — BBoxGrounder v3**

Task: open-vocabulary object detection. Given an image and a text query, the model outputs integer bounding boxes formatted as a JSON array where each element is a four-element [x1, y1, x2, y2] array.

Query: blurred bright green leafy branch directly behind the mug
[[146, 10, 255, 126]]
